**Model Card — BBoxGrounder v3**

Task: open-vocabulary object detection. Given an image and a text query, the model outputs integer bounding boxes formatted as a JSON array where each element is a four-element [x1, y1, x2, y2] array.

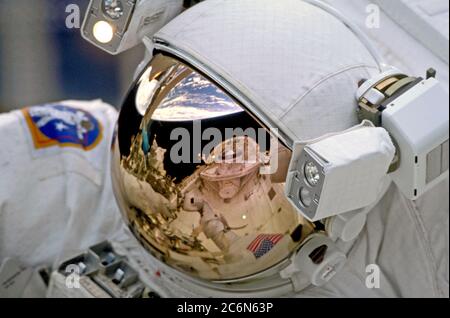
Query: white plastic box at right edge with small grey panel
[[382, 78, 449, 200]]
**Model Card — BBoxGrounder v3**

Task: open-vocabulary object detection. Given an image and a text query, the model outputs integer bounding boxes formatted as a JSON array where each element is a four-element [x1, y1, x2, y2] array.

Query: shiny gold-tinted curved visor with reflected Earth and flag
[[112, 54, 313, 281]]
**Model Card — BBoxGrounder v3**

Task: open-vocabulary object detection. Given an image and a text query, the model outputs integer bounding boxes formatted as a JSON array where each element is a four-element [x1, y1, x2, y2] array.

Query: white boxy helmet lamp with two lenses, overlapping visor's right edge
[[286, 126, 395, 222]]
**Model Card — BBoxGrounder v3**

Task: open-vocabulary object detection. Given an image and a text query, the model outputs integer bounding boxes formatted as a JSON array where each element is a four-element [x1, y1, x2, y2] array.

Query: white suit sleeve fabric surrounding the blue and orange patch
[[0, 101, 121, 265]]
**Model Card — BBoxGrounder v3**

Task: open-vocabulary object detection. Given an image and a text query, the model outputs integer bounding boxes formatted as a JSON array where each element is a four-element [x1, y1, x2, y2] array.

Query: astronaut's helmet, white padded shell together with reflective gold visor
[[112, 0, 379, 286]]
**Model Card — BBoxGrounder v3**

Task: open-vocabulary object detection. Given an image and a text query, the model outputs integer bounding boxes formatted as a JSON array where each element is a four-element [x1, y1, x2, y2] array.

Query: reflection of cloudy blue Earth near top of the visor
[[152, 73, 243, 121]]
